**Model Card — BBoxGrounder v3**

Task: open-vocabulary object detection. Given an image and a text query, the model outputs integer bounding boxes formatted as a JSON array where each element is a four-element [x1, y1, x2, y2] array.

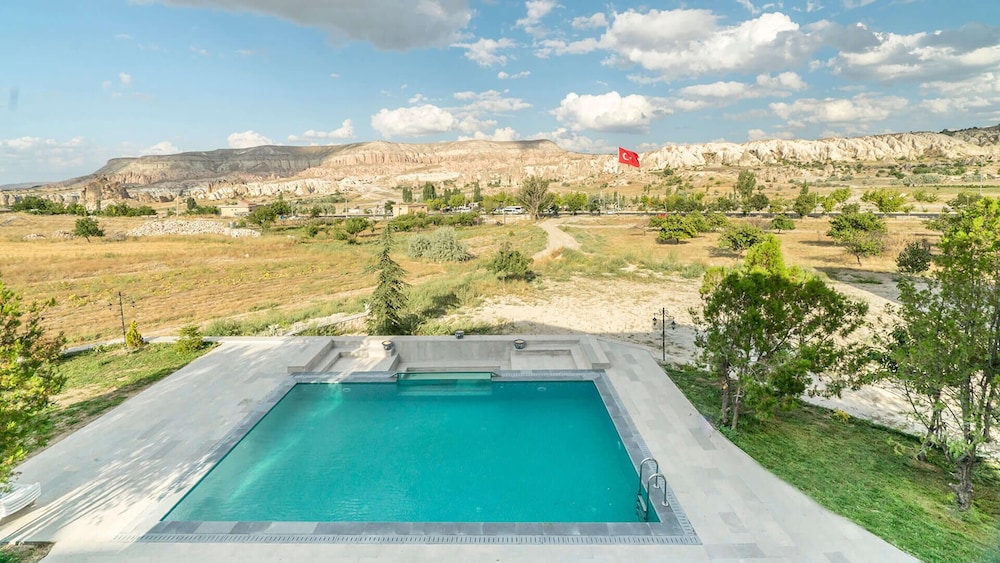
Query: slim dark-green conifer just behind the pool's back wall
[[366, 224, 409, 336]]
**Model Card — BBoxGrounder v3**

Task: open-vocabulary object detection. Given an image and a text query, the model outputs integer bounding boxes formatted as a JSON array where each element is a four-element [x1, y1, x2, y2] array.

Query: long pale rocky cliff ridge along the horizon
[[0, 125, 1000, 205]]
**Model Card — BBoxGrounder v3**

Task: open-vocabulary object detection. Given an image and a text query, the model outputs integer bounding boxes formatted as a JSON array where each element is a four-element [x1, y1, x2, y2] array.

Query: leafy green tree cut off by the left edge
[[0, 281, 66, 484]]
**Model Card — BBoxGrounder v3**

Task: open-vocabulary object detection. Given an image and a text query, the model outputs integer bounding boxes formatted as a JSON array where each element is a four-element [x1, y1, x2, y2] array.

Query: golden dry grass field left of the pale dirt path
[[0, 213, 544, 343]]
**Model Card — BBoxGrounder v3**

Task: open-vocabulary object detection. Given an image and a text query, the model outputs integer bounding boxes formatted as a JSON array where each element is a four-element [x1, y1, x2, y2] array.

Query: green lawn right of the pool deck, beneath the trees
[[666, 368, 1000, 562]]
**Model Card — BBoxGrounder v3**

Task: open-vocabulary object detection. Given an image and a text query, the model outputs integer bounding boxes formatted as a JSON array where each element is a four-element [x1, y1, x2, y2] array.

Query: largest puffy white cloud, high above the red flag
[[600, 9, 818, 79]]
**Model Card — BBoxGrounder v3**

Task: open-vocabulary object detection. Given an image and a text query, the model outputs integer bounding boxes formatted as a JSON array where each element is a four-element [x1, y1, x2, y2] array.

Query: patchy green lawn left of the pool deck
[[45, 344, 212, 450]]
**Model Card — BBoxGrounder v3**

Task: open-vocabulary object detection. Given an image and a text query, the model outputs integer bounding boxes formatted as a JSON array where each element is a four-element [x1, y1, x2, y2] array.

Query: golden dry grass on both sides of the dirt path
[[0, 213, 932, 344]]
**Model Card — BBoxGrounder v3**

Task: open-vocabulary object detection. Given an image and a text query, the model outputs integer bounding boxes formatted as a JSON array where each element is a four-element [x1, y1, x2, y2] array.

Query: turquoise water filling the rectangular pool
[[164, 381, 637, 522]]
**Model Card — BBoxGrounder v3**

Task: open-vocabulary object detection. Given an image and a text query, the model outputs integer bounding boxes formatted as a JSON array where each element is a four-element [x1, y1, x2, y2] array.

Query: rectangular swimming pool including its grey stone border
[[148, 369, 701, 545]]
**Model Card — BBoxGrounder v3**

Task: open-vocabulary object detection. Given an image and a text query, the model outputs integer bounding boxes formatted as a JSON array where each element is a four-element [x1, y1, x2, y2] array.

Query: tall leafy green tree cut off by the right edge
[[881, 198, 1000, 511]]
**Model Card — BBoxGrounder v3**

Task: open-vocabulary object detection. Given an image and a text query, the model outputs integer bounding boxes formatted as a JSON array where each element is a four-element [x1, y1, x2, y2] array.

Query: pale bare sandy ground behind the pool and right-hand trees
[[454, 219, 1000, 459]]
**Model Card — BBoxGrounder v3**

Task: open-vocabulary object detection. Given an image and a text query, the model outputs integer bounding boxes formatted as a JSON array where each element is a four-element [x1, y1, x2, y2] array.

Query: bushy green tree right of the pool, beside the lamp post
[[692, 240, 867, 430]]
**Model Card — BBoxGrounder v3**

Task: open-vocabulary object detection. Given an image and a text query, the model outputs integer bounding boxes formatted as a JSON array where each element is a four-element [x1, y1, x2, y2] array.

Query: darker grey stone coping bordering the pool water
[[139, 369, 702, 545]]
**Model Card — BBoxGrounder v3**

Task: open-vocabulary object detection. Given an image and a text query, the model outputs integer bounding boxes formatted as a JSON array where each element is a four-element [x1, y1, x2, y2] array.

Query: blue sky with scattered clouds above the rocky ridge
[[0, 0, 1000, 184]]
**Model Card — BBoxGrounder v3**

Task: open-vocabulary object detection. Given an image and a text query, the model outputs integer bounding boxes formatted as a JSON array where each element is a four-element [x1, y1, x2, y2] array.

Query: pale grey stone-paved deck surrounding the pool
[[0, 336, 915, 563]]
